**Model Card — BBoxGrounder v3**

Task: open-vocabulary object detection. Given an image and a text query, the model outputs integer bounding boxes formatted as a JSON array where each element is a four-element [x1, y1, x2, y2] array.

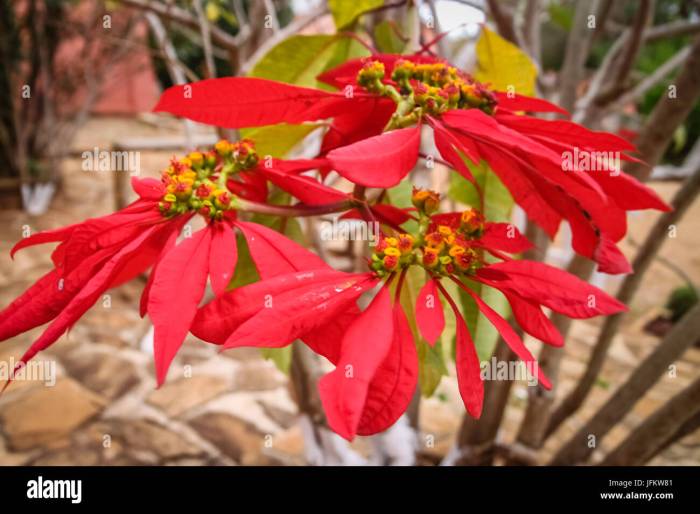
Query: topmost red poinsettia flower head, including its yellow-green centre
[[156, 55, 668, 273]]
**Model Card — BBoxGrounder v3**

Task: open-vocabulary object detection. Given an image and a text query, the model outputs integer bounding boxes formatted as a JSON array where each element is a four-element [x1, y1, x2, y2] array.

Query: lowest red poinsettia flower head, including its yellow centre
[[192, 197, 625, 439]]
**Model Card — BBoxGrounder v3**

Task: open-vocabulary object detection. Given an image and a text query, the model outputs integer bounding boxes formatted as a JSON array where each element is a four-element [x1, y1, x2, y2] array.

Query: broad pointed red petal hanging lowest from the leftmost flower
[[148, 227, 212, 386]]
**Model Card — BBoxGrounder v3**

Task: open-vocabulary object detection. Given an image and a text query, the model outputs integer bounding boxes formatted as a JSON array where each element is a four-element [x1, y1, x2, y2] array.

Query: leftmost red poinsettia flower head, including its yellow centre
[[0, 141, 345, 384]]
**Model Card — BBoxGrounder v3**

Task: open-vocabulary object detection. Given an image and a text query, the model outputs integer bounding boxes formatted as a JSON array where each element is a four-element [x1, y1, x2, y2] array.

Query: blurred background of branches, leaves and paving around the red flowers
[[0, 0, 700, 465]]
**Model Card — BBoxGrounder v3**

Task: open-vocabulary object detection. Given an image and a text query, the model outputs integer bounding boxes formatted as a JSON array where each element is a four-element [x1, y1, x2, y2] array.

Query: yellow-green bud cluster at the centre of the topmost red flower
[[357, 59, 496, 128]]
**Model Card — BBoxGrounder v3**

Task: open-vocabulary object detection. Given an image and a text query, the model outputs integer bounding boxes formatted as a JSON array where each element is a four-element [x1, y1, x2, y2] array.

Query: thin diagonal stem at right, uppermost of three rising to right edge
[[546, 169, 700, 436]]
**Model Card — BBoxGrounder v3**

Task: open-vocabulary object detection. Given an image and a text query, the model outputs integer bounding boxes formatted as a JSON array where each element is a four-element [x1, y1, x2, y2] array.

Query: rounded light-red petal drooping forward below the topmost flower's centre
[[327, 126, 420, 187]]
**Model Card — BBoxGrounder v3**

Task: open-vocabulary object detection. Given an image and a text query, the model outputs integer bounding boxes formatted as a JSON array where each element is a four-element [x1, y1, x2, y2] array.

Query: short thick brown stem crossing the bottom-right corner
[[601, 372, 700, 466]]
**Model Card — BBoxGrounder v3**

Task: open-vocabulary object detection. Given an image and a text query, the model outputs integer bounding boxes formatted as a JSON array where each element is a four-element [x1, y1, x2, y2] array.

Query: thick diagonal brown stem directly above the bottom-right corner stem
[[550, 304, 700, 466]]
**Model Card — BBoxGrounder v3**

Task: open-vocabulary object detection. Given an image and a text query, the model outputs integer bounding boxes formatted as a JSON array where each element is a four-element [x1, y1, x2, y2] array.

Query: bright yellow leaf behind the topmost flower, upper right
[[474, 27, 537, 96]]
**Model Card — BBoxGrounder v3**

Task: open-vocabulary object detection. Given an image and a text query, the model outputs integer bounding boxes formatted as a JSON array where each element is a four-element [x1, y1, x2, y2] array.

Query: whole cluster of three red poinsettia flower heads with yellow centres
[[0, 29, 667, 439]]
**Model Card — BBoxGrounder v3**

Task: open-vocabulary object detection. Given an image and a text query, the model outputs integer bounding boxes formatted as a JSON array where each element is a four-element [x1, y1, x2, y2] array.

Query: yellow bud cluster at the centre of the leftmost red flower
[[158, 139, 258, 220]]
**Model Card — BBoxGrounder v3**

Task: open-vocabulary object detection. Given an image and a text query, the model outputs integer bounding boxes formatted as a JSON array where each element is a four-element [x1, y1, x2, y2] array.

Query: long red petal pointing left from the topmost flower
[[153, 77, 361, 128]]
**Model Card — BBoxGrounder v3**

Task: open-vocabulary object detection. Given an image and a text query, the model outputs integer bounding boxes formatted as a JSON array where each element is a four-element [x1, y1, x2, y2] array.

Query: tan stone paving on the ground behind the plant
[[0, 116, 700, 465]]
